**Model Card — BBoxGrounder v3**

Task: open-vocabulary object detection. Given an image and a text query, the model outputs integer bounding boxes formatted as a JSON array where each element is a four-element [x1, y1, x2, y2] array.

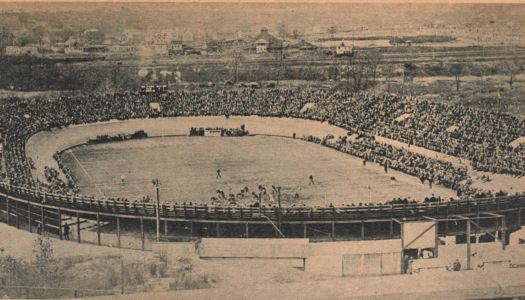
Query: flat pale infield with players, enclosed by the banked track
[[58, 136, 454, 206]]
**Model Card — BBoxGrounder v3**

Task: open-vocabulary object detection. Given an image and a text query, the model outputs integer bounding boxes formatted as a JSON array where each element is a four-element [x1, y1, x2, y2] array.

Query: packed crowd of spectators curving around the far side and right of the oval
[[0, 89, 525, 206]]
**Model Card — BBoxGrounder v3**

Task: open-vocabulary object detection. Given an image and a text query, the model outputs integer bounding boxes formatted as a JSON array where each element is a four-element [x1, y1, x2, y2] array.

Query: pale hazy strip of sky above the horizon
[[0, 0, 525, 28]]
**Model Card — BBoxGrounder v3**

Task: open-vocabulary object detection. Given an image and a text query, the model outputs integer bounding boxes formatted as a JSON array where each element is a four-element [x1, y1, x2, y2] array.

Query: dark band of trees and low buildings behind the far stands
[[0, 52, 525, 92]]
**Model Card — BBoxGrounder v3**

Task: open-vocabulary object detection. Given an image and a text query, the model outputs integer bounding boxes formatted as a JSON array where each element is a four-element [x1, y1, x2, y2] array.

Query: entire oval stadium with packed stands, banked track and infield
[[0, 89, 525, 273]]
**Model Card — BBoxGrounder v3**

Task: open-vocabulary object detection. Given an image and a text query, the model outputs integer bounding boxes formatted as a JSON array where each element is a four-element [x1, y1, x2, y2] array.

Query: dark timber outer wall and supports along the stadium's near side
[[0, 183, 525, 248]]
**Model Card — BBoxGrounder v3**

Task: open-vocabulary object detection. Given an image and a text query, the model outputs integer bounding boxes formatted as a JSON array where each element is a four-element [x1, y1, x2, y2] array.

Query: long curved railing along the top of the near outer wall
[[0, 183, 525, 222]]
